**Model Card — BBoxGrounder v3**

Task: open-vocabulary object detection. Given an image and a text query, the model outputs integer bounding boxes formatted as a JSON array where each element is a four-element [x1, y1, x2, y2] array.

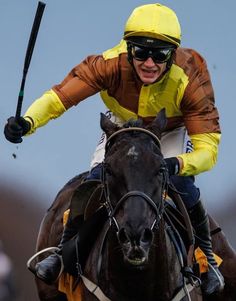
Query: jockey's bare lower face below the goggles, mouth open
[[133, 57, 167, 84]]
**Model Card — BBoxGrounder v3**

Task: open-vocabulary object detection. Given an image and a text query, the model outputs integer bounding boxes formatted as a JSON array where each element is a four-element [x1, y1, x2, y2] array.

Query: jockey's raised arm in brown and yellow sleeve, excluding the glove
[[24, 55, 113, 135]]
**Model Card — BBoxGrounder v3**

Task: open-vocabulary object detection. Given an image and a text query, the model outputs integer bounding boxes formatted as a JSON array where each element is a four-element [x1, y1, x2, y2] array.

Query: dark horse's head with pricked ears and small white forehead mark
[[101, 110, 166, 267]]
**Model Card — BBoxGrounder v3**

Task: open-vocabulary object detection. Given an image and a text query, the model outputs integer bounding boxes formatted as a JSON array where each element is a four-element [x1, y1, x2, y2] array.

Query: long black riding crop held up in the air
[[15, 1, 46, 119]]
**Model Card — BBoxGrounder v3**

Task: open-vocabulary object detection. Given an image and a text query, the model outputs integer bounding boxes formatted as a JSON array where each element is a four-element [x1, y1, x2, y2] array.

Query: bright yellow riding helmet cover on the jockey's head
[[124, 3, 181, 47]]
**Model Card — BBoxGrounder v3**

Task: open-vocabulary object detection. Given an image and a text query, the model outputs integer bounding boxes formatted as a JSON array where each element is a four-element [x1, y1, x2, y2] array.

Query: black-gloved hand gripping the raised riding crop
[[4, 116, 31, 143]]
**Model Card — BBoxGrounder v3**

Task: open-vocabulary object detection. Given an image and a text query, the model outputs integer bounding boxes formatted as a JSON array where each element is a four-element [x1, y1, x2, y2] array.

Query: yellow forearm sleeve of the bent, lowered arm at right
[[178, 133, 221, 176]]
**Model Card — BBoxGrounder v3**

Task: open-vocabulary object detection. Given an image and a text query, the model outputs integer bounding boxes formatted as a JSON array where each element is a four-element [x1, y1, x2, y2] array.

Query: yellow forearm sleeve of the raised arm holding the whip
[[24, 90, 66, 135]]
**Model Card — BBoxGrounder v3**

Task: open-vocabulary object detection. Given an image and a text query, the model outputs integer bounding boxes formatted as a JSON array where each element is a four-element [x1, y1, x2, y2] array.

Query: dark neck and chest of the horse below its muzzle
[[95, 219, 183, 301]]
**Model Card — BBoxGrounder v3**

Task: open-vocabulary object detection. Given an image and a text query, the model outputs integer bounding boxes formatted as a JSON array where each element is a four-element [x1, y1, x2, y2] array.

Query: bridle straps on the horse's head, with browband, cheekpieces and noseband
[[102, 127, 168, 232]]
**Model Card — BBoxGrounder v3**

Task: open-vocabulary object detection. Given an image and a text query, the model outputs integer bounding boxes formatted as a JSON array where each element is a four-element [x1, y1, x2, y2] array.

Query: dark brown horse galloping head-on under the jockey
[[32, 111, 236, 301]]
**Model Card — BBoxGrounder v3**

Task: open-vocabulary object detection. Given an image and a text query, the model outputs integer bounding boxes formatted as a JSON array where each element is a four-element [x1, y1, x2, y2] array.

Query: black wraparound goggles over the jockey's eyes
[[131, 45, 174, 64]]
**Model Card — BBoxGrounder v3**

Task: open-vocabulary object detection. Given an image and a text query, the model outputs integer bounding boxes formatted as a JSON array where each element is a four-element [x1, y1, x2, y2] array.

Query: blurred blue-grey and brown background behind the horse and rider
[[0, 0, 236, 301]]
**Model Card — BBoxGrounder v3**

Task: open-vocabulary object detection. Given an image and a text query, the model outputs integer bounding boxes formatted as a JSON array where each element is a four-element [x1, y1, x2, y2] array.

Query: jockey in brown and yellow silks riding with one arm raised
[[4, 3, 224, 295]]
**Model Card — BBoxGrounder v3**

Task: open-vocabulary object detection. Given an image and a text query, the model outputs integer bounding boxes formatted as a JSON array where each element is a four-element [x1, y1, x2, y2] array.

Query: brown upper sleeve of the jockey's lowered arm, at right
[[177, 49, 220, 135]]
